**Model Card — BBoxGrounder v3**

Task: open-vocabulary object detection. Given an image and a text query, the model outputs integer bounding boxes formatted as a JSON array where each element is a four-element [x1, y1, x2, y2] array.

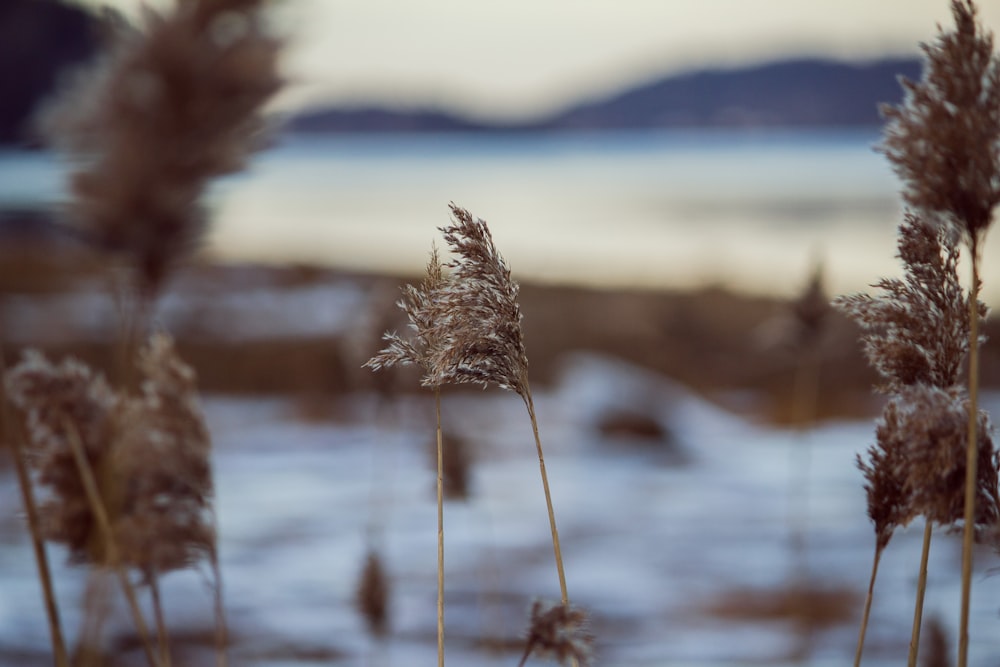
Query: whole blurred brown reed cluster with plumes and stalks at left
[[3, 0, 281, 667]]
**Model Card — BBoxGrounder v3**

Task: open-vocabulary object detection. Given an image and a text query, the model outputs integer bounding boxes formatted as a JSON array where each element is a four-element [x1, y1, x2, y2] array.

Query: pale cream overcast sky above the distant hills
[[68, 0, 1000, 119]]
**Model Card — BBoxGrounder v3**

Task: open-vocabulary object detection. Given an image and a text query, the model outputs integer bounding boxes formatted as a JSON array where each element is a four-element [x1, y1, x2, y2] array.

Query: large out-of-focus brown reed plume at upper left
[[42, 0, 281, 295]]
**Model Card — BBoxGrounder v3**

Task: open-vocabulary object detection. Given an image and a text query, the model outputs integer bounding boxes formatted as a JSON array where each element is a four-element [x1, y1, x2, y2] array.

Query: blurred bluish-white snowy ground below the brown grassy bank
[[0, 356, 1000, 667]]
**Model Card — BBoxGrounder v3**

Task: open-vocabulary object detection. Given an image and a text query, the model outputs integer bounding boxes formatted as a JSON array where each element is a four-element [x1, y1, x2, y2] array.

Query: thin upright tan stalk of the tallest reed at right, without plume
[[958, 241, 979, 667]]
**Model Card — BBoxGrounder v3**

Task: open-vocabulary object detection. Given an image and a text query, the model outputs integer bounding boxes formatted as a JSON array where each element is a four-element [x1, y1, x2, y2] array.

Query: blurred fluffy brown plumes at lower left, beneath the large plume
[[6, 335, 224, 664]]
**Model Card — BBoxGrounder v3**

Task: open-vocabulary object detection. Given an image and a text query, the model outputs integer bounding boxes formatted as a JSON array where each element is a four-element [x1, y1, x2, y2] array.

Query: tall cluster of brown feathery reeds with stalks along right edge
[[837, 0, 1000, 667]]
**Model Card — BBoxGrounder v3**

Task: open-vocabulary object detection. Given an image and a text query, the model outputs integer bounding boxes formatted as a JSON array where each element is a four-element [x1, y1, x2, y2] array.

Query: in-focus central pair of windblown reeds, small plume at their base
[[365, 204, 593, 665]]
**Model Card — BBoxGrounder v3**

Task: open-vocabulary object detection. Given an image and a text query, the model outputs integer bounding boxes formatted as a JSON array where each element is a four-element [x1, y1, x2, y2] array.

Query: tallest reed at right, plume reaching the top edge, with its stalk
[[882, 0, 1000, 667]]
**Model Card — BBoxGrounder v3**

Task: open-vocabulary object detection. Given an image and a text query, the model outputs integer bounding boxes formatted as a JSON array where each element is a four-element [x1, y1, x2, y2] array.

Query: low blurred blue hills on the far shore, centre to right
[[290, 58, 921, 132]]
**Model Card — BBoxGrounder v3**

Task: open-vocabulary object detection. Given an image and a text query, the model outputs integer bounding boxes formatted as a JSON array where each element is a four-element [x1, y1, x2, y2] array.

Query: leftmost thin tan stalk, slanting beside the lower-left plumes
[[0, 351, 69, 667]]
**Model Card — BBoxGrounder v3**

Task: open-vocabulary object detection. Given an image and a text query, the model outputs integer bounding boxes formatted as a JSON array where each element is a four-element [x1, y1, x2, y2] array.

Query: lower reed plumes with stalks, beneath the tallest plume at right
[[835, 212, 1000, 665]]
